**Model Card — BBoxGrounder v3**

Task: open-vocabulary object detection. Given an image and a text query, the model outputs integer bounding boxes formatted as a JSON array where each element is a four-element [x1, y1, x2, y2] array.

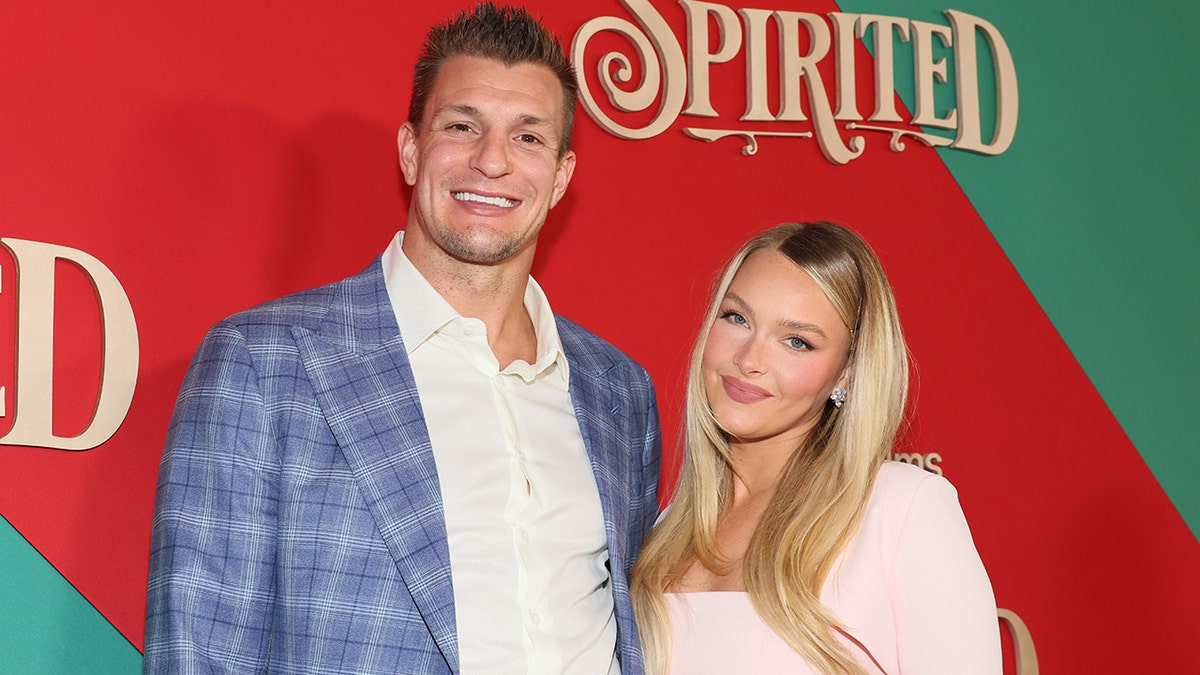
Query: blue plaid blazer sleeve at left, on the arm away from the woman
[[144, 324, 278, 673]]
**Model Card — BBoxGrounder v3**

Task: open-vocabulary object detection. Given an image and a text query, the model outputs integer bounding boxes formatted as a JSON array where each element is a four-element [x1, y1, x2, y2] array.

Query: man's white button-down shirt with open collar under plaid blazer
[[383, 233, 620, 675]]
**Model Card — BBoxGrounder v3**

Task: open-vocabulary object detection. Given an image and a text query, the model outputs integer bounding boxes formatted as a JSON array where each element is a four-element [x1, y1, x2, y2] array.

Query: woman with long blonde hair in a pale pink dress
[[632, 223, 1001, 675]]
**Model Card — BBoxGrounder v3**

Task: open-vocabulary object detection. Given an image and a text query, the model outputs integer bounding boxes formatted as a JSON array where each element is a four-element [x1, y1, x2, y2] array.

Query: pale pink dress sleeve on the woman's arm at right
[[888, 474, 1002, 675]]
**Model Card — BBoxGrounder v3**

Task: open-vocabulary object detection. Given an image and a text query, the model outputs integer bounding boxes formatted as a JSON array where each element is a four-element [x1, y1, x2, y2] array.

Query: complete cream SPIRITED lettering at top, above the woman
[[571, 0, 1018, 165]]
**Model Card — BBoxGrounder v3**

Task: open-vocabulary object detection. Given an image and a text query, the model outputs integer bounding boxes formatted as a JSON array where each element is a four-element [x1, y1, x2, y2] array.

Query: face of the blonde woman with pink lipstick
[[701, 251, 850, 453]]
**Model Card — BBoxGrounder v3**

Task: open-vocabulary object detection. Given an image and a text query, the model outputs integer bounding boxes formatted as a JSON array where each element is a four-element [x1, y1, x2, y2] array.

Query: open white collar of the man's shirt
[[382, 231, 570, 388]]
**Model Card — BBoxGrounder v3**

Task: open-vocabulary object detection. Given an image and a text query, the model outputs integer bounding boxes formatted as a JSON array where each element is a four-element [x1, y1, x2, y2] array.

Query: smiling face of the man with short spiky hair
[[398, 55, 575, 264]]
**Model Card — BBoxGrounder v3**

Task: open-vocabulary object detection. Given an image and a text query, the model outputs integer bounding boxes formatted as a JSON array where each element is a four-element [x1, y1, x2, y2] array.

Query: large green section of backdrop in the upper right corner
[[840, 0, 1200, 536]]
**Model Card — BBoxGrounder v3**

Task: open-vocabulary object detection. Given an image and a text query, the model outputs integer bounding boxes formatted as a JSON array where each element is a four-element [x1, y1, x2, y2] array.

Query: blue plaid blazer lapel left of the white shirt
[[294, 262, 458, 673]]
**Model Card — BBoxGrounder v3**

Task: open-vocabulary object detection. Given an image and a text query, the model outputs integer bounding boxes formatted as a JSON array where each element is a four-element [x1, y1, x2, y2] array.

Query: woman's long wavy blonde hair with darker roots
[[631, 222, 908, 674]]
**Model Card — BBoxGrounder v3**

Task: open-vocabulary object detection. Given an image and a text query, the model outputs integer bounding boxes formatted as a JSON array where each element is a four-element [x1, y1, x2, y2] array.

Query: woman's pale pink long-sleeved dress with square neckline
[[666, 461, 1002, 675]]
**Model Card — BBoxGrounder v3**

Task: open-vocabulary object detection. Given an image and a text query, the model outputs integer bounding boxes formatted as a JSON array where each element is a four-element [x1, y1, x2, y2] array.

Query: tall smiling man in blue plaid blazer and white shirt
[[145, 5, 660, 675]]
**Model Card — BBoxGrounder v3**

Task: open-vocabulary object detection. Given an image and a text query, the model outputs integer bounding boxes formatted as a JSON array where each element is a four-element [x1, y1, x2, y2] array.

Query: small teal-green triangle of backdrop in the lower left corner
[[0, 518, 142, 675]]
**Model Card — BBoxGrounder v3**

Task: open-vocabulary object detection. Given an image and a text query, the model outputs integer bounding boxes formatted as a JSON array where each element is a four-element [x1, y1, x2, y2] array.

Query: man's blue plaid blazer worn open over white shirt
[[144, 259, 661, 675]]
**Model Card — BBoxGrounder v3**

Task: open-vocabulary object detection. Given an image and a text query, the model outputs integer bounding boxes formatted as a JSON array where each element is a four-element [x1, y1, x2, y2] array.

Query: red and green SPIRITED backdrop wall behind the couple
[[0, 0, 1200, 675]]
